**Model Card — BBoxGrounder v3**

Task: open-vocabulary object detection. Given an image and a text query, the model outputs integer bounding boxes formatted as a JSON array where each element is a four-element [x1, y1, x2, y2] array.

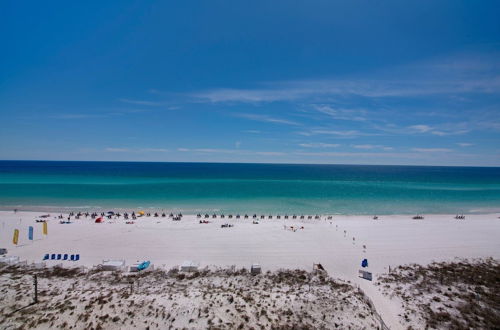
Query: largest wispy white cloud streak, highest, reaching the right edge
[[190, 54, 500, 103]]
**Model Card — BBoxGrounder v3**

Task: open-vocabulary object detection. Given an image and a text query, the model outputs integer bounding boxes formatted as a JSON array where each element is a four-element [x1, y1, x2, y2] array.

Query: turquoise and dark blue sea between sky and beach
[[0, 161, 500, 214]]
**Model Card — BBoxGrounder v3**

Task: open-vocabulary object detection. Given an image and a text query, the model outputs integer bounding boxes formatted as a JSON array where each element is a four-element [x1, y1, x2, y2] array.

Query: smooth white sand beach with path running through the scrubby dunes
[[0, 211, 500, 329]]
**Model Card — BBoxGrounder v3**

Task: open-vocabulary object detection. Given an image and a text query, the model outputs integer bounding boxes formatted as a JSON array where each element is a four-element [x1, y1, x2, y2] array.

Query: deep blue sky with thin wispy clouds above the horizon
[[0, 0, 500, 166]]
